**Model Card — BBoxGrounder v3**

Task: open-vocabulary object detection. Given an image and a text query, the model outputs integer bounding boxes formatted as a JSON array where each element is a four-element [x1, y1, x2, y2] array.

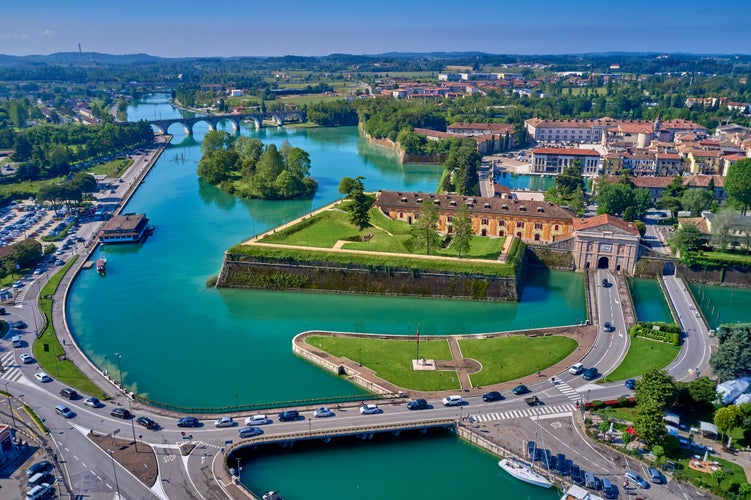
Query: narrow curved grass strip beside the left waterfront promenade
[[33, 256, 104, 397]]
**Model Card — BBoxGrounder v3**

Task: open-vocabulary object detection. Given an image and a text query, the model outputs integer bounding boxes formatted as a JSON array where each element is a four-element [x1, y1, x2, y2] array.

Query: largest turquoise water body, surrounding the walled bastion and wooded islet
[[66, 94, 584, 408]]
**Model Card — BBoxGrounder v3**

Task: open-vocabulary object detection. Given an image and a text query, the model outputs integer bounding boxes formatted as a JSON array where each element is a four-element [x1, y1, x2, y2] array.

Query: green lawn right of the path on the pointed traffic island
[[459, 335, 578, 386]]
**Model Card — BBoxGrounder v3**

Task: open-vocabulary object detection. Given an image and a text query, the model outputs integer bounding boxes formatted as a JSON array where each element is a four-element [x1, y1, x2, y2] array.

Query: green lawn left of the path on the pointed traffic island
[[305, 336, 459, 391]]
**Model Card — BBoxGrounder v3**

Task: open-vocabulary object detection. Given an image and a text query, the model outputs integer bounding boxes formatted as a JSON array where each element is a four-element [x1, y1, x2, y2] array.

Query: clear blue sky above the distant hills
[[0, 0, 751, 57]]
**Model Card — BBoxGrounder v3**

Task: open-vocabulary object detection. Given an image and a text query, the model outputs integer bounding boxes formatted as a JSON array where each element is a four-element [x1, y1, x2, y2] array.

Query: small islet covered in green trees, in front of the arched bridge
[[198, 130, 318, 200]]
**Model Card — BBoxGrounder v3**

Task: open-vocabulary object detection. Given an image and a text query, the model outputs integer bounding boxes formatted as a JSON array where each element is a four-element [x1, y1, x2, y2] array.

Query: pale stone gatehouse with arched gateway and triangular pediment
[[573, 214, 641, 274]]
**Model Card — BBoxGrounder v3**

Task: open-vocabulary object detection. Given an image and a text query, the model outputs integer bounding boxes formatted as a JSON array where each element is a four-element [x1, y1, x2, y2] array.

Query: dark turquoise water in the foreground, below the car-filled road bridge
[[241, 431, 560, 500]]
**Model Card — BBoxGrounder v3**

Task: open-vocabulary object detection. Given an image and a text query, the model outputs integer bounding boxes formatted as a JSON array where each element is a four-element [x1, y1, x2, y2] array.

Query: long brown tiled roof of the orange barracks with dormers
[[375, 191, 574, 220]]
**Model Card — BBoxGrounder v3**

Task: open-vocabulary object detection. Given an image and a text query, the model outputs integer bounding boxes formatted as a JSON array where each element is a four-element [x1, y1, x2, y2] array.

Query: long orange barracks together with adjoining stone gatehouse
[[375, 191, 640, 273]]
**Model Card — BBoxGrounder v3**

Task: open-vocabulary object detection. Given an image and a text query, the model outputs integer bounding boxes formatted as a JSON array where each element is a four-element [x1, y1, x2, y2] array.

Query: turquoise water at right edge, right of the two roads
[[689, 283, 751, 328]]
